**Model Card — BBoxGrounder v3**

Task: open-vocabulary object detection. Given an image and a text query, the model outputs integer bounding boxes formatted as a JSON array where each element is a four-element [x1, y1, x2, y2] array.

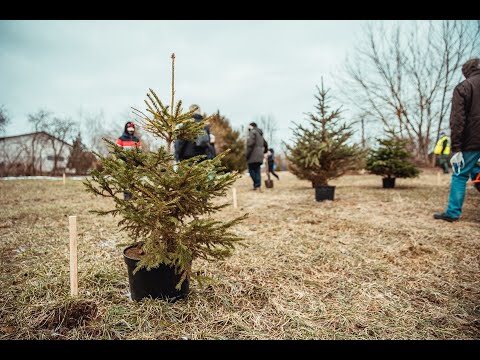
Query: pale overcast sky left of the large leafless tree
[[0, 20, 390, 148]]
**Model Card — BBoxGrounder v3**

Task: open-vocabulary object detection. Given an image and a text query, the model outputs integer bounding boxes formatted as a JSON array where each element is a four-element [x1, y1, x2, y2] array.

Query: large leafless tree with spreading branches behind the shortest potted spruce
[[341, 20, 480, 163]]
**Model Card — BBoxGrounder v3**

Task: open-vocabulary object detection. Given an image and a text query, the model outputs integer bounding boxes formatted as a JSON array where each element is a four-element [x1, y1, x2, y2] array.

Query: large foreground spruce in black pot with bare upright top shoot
[[84, 54, 246, 301]]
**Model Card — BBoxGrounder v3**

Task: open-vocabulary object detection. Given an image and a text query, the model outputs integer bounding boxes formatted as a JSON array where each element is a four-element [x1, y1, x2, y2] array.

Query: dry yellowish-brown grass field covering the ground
[[0, 172, 480, 339]]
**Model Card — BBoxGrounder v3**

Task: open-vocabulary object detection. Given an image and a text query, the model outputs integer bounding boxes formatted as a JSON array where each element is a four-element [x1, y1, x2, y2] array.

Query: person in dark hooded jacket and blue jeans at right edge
[[433, 58, 480, 222]]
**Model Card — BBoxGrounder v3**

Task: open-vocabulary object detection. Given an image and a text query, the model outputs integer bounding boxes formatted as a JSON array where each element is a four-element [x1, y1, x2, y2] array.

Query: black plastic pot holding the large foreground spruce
[[123, 245, 189, 302]]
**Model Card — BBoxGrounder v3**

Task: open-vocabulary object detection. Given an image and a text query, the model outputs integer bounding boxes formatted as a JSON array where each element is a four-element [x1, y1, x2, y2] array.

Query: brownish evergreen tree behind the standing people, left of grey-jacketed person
[[210, 111, 247, 172]]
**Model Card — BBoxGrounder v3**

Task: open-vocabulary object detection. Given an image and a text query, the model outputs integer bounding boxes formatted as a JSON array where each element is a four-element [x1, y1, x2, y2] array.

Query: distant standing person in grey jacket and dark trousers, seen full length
[[246, 122, 267, 190]]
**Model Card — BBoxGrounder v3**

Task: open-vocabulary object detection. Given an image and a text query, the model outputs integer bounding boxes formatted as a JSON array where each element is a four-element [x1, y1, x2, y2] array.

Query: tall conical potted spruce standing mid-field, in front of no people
[[285, 80, 365, 201]]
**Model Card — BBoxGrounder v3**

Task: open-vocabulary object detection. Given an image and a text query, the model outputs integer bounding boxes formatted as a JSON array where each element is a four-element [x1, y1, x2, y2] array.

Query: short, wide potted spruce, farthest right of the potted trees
[[366, 137, 419, 189]]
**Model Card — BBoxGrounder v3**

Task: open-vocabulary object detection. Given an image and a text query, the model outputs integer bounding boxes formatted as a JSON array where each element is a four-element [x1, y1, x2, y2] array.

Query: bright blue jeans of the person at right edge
[[445, 151, 480, 218]]
